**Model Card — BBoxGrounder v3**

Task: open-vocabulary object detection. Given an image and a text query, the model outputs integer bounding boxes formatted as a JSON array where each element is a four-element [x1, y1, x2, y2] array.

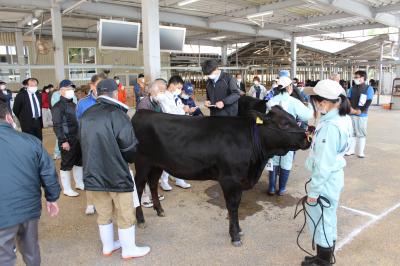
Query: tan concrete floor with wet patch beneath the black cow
[[18, 104, 400, 266]]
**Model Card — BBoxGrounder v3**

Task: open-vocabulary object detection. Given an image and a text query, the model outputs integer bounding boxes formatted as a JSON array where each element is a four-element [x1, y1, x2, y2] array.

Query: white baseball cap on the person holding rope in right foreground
[[303, 79, 346, 100]]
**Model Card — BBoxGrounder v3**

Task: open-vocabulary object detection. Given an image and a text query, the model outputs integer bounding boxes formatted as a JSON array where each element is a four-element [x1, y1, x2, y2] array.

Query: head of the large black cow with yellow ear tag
[[256, 106, 311, 156]]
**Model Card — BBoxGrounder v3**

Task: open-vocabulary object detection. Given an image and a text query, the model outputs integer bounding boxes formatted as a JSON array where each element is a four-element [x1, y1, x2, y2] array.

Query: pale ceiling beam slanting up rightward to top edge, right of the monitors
[[208, 0, 305, 22]]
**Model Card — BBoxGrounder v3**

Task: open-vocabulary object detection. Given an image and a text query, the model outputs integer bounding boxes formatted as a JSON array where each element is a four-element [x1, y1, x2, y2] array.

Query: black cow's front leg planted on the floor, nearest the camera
[[220, 179, 242, 247]]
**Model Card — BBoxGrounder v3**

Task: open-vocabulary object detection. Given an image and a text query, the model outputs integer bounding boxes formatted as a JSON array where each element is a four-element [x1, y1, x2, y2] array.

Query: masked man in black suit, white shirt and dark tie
[[13, 78, 43, 140]]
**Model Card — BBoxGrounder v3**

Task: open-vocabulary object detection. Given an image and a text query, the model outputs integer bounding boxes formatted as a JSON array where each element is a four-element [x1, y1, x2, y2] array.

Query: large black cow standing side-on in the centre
[[132, 106, 310, 246]]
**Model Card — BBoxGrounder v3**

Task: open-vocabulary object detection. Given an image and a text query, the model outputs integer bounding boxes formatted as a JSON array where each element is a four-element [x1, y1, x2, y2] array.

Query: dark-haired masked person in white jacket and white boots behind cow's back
[[157, 76, 191, 191]]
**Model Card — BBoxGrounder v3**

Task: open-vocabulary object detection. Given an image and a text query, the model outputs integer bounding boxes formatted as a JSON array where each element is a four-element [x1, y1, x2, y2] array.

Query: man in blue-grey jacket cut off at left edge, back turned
[[0, 102, 61, 266]]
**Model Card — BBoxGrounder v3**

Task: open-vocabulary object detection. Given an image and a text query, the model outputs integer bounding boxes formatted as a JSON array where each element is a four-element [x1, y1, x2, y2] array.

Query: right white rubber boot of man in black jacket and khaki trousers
[[118, 226, 150, 260]]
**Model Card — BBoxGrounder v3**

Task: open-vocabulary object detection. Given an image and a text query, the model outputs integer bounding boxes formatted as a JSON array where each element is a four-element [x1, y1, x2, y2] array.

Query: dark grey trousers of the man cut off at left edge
[[0, 220, 40, 266]]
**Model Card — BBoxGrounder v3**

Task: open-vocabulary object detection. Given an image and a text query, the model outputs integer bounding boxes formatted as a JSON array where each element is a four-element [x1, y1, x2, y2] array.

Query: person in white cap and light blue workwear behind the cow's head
[[267, 76, 313, 196]]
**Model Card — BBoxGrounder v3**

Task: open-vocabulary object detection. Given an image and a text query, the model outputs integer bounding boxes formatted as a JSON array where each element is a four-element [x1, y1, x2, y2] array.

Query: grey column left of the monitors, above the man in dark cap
[[51, 0, 65, 84]]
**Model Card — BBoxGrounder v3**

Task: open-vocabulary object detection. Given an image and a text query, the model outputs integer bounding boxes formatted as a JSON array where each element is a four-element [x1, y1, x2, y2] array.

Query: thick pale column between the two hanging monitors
[[142, 0, 161, 81]]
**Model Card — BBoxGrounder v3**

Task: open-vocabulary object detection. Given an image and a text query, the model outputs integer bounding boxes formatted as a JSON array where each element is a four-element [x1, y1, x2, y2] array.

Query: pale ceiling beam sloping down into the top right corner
[[314, 0, 400, 28]]
